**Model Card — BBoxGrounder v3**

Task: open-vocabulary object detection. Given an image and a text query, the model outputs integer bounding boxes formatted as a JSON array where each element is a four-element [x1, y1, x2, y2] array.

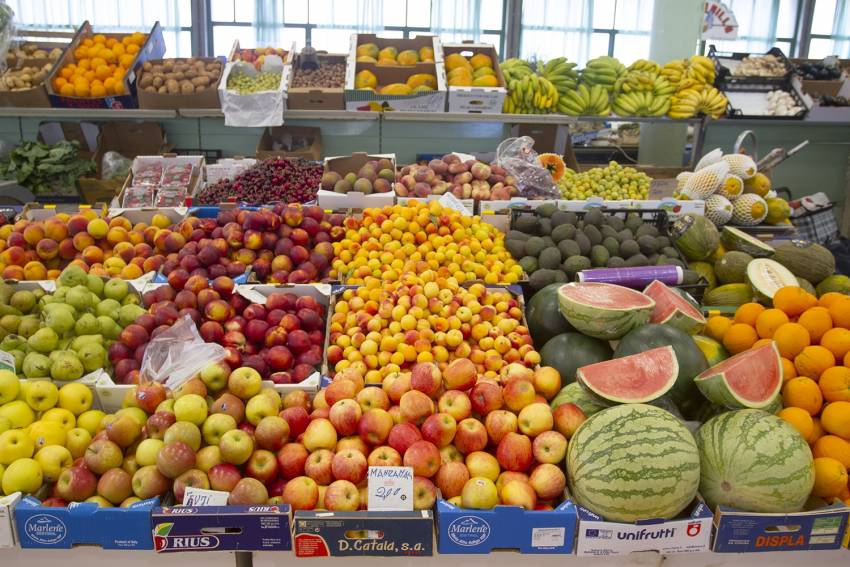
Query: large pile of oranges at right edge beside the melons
[[705, 286, 850, 504]]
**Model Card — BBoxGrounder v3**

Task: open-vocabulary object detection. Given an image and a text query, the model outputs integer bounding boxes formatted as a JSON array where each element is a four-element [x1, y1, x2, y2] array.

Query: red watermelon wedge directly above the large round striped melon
[[576, 346, 679, 404]]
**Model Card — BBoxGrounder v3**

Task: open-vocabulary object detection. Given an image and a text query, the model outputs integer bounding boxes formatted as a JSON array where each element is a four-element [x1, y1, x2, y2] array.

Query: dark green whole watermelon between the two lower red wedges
[[614, 325, 708, 417]]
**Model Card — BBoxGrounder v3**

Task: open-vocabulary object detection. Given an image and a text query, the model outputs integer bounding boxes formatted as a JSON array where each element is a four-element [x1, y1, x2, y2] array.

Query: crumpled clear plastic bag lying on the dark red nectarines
[[139, 315, 225, 390]]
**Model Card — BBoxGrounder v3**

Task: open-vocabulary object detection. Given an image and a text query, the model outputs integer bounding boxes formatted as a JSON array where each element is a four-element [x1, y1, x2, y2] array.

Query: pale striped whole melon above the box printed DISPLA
[[696, 409, 815, 513]]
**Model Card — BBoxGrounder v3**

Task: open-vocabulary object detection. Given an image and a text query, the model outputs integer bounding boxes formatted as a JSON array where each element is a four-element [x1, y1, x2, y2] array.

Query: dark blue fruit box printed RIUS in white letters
[[154, 504, 292, 553]]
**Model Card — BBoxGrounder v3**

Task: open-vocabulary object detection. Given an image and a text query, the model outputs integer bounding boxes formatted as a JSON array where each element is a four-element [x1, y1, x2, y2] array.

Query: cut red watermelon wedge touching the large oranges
[[694, 342, 782, 409]]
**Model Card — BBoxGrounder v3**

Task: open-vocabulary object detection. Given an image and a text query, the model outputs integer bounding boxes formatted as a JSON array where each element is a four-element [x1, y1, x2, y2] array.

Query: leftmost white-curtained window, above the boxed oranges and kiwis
[[6, 0, 192, 57]]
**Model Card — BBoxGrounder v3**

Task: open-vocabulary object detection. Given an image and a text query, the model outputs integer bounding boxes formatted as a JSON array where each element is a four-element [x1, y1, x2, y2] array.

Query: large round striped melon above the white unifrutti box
[[567, 404, 700, 522]]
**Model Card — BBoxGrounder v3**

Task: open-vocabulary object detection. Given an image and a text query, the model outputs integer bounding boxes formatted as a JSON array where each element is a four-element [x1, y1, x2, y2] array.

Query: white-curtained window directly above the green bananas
[[520, 0, 655, 65]]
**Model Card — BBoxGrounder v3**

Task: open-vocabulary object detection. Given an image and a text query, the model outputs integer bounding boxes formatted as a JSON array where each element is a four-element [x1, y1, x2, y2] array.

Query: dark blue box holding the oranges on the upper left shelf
[[46, 21, 165, 108]]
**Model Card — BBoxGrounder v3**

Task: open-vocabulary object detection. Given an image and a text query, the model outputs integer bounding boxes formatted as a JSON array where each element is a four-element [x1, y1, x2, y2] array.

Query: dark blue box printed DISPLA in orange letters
[[713, 501, 850, 553]]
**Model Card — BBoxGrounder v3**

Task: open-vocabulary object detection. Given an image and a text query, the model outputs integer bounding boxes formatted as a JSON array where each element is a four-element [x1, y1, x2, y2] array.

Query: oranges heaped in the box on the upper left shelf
[[53, 32, 147, 97]]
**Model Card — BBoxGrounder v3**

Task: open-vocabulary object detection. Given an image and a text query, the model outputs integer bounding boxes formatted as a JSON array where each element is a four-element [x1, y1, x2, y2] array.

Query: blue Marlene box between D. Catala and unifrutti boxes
[[437, 498, 577, 553]]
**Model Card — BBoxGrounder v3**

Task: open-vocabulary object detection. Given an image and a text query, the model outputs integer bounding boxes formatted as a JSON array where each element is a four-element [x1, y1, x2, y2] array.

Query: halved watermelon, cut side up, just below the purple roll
[[558, 282, 655, 340]]
